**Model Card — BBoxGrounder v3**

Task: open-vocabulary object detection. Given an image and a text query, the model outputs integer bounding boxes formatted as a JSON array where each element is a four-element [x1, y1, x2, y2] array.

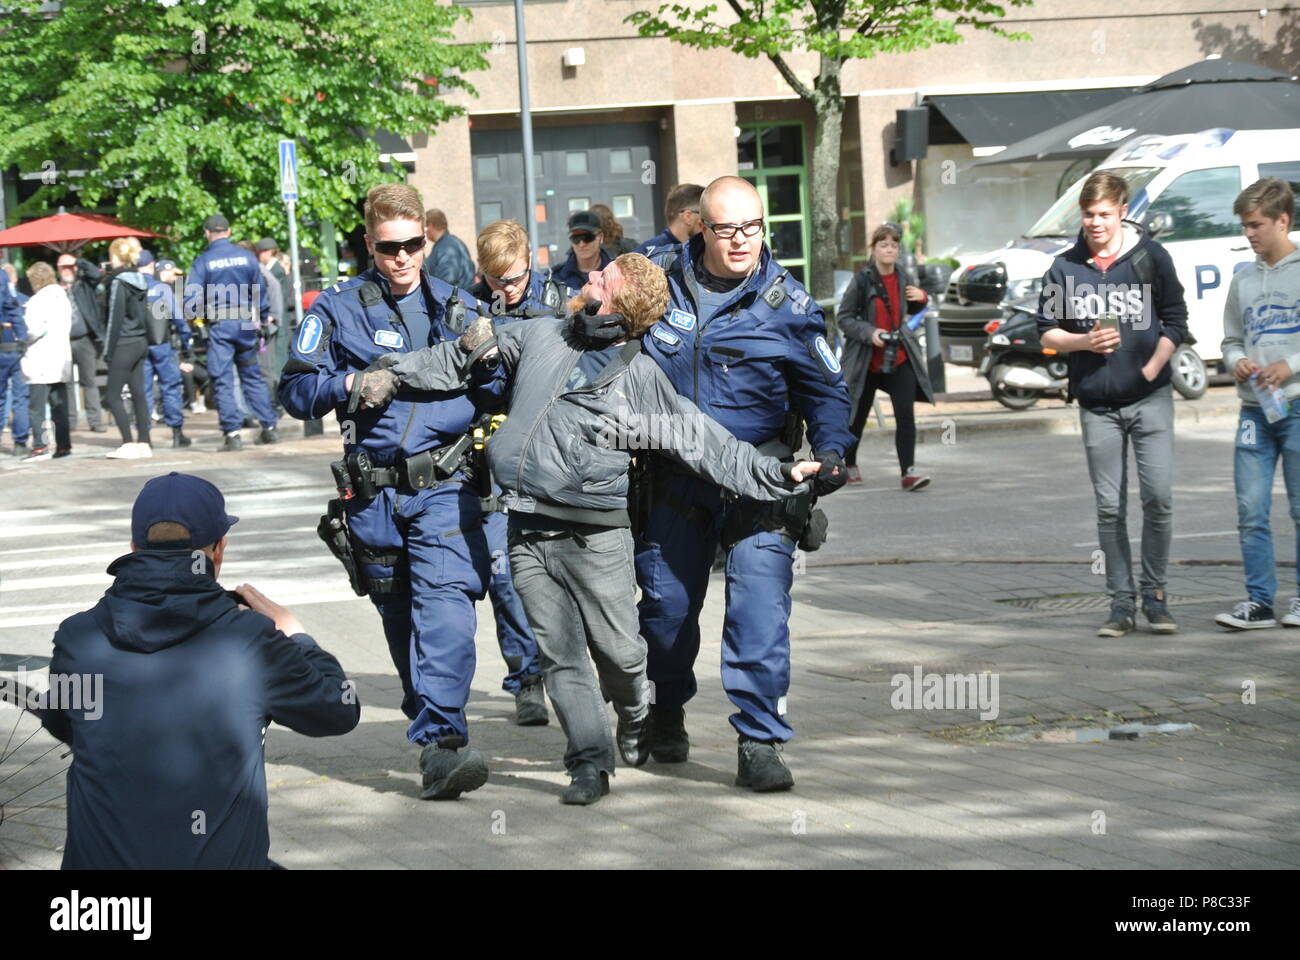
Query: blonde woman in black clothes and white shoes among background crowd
[[104, 237, 156, 460]]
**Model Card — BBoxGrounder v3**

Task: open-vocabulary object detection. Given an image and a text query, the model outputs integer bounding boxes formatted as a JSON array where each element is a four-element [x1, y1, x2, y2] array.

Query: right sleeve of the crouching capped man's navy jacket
[[260, 627, 361, 736]]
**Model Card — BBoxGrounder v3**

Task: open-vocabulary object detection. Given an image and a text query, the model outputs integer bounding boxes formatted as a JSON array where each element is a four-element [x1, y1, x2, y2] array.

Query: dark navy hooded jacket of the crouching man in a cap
[[43, 549, 361, 869]]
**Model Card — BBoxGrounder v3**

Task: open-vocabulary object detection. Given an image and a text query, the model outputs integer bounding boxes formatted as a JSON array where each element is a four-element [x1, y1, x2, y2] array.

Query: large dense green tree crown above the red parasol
[[0, 0, 486, 259]]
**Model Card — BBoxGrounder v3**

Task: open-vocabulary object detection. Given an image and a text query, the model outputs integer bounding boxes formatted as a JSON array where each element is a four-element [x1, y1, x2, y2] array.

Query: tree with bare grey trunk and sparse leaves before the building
[[628, 0, 1031, 297]]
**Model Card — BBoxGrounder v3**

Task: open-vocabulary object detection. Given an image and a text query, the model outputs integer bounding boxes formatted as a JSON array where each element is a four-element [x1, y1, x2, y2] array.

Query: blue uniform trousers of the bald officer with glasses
[[636, 472, 794, 741]]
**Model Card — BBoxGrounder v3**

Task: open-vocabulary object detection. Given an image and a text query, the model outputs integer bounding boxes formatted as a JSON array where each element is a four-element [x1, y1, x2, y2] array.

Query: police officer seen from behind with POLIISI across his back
[[185, 213, 280, 450]]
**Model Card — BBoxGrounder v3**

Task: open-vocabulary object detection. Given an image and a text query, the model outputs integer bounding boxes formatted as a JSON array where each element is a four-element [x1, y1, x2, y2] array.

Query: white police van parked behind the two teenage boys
[[939, 127, 1300, 380]]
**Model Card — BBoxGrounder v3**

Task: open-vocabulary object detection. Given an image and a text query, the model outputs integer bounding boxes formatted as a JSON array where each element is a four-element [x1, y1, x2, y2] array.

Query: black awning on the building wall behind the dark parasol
[[923, 87, 1134, 147]]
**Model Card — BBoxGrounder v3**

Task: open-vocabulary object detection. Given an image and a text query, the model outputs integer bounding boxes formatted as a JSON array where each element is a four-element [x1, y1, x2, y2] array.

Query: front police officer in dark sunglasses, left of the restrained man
[[280, 183, 491, 800]]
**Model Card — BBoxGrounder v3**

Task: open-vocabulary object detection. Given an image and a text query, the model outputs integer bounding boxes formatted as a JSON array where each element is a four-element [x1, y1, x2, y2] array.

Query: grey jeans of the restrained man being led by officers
[[510, 514, 650, 774]]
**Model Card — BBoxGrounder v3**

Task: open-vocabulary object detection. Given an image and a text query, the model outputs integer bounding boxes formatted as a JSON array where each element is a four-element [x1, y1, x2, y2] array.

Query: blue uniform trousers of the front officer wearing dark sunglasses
[[347, 481, 491, 744]]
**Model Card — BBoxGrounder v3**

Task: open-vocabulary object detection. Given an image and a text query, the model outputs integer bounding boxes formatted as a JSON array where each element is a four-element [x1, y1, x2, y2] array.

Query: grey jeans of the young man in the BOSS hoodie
[[1079, 385, 1174, 606]]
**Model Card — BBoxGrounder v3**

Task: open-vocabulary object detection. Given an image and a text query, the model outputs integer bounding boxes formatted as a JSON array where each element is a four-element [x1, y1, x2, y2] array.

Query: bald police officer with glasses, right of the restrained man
[[636, 177, 852, 791]]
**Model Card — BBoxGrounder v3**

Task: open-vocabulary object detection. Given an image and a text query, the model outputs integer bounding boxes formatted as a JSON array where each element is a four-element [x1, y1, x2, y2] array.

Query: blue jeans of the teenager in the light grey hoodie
[[1232, 403, 1300, 607]]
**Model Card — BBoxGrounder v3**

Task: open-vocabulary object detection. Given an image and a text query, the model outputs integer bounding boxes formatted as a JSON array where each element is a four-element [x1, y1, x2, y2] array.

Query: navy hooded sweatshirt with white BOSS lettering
[[1037, 221, 1191, 410]]
